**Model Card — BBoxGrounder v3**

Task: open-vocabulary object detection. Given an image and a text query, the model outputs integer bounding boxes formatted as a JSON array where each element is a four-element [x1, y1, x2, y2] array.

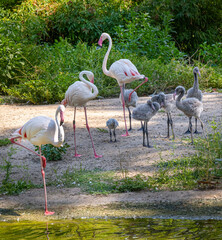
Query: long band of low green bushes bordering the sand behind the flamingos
[[3, 39, 222, 104]]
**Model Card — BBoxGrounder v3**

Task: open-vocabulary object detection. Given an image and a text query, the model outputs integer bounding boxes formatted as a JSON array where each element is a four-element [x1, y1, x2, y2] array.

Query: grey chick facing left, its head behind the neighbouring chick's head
[[151, 92, 175, 139]]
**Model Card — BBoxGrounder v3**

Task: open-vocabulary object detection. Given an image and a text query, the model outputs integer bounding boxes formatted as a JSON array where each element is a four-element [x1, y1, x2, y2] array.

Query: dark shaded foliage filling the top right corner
[[143, 0, 222, 54]]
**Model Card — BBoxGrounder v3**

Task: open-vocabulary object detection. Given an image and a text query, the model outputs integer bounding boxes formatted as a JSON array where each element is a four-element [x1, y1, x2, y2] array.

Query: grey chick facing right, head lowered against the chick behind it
[[133, 100, 160, 147]]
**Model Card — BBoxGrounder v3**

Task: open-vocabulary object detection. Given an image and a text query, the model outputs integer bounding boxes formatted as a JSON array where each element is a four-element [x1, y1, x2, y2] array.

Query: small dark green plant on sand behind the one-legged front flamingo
[[35, 143, 70, 161]]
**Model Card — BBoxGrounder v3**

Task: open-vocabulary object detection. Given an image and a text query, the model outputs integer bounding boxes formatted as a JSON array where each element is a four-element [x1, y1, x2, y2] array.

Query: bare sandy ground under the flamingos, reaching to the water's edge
[[0, 93, 222, 219]]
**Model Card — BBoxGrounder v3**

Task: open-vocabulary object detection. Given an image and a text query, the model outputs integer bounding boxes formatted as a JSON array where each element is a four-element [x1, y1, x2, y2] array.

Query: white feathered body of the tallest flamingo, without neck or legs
[[109, 59, 145, 86]]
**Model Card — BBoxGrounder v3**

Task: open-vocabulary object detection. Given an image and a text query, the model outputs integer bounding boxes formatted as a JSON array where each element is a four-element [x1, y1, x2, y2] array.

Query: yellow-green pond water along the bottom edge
[[0, 218, 222, 240]]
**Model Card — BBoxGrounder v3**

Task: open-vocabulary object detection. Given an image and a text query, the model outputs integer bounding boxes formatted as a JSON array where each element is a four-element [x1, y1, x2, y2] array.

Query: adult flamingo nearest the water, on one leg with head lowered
[[10, 105, 65, 215]]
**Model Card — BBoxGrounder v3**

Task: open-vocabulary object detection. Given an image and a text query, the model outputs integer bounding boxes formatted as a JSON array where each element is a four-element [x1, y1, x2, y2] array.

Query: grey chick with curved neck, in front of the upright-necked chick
[[174, 86, 204, 143]]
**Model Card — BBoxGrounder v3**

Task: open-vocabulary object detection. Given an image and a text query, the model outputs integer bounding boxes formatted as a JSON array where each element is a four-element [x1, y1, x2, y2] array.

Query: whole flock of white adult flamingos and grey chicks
[[10, 33, 204, 215]]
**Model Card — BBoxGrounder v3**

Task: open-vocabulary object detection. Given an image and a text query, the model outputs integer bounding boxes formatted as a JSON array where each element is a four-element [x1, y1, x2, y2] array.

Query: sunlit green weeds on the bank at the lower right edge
[[153, 121, 222, 190]]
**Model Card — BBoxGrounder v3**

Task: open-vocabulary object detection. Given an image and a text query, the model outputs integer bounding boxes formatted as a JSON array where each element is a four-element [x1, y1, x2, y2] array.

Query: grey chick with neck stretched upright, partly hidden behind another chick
[[185, 67, 203, 134]]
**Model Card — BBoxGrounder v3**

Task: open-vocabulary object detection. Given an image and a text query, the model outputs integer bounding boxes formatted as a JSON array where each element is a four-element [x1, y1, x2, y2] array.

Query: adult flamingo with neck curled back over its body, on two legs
[[62, 71, 102, 158]]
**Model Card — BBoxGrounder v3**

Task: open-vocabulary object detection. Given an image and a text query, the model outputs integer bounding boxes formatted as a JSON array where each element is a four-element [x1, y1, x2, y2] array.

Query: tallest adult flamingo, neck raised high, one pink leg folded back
[[98, 33, 148, 136]]
